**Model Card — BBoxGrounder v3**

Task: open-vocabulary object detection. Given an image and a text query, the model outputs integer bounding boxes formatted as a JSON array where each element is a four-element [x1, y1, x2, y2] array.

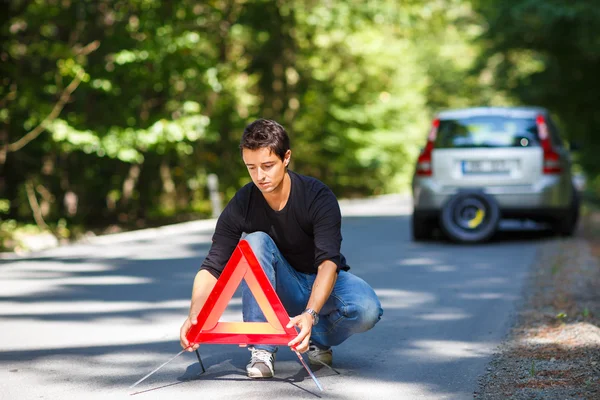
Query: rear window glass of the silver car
[[435, 116, 539, 149]]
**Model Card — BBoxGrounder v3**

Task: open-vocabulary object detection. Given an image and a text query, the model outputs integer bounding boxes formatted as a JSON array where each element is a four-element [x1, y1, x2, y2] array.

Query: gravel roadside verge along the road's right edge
[[474, 213, 600, 400]]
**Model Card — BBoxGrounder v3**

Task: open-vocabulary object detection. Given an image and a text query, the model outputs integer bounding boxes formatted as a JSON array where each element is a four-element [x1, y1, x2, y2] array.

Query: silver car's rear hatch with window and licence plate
[[431, 113, 544, 187]]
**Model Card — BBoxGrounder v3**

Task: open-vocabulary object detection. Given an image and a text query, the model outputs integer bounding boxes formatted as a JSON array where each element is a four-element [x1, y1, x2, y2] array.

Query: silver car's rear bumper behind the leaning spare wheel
[[413, 176, 572, 215]]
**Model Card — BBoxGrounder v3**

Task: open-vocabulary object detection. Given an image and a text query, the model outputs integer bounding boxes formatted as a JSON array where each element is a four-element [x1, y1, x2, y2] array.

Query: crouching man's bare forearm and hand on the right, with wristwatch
[[287, 260, 337, 353]]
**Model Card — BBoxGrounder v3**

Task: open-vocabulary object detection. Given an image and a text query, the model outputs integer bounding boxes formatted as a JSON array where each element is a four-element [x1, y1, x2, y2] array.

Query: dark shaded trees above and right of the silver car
[[473, 0, 600, 195]]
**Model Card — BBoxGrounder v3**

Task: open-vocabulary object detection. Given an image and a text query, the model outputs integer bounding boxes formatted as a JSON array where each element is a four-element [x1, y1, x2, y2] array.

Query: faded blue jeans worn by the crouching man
[[242, 232, 383, 352]]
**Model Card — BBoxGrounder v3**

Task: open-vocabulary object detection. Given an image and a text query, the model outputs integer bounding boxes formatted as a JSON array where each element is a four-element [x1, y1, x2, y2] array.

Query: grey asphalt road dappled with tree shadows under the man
[[0, 196, 547, 400]]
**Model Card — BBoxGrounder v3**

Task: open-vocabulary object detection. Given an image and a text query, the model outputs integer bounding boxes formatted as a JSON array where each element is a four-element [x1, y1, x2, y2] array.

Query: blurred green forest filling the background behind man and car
[[0, 0, 600, 249]]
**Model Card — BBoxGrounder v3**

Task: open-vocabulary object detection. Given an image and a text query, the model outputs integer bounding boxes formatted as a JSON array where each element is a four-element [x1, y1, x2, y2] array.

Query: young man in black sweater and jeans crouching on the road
[[180, 119, 383, 378]]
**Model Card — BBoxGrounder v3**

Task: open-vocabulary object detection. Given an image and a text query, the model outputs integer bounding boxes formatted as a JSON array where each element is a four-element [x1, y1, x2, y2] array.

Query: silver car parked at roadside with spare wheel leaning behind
[[412, 107, 579, 242]]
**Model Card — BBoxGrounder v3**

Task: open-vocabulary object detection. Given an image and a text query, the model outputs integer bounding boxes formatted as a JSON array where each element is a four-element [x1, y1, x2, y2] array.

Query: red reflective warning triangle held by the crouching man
[[186, 240, 298, 346]]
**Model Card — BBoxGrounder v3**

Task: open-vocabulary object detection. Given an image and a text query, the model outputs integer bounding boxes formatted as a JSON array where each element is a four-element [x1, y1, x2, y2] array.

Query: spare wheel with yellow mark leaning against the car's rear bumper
[[440, 191, 500, 243]]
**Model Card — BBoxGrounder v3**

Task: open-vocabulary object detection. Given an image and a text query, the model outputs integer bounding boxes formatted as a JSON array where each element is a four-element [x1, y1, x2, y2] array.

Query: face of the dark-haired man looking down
[[242, 147, 292, 193]]
